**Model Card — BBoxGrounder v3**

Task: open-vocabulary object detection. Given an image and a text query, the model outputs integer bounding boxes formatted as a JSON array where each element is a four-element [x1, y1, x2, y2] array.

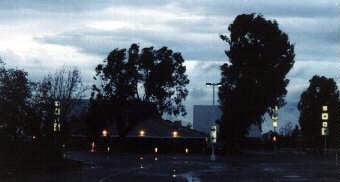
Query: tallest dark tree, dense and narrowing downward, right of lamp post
[[219, 14, 295, 152]]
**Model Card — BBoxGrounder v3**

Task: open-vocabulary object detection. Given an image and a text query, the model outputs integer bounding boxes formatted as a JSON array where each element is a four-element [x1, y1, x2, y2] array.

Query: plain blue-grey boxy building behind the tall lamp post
[[193, 105, 222, 133]]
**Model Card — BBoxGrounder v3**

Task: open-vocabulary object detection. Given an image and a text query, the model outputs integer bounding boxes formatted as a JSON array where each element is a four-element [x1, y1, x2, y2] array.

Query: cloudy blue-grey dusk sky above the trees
[[0, 0, 340, 130]]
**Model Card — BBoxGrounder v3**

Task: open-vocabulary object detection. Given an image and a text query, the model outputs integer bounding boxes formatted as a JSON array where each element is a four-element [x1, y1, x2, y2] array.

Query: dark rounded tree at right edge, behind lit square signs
[[298, 75, 340, 147]]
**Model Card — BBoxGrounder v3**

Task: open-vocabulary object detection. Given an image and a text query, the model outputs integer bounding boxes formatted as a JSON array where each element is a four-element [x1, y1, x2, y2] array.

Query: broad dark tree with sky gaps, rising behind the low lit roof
[[88, 44, 189, 136]]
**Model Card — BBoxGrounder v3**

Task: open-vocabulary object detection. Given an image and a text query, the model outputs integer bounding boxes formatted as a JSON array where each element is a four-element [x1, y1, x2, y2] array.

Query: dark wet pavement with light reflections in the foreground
[[0, 151, 337, 182]]
